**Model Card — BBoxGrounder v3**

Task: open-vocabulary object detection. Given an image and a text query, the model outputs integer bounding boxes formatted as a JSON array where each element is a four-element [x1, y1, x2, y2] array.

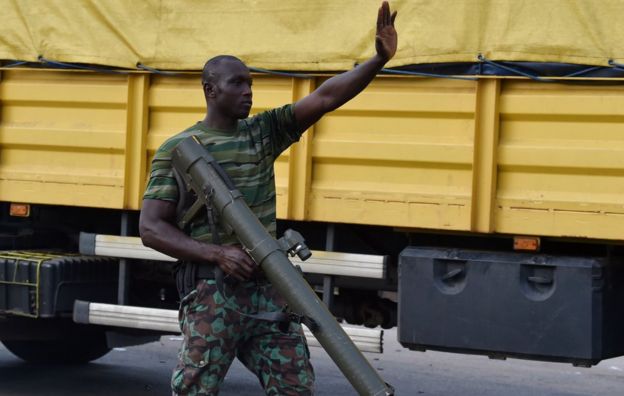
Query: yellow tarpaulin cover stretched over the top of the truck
[[0, 0, 624, 71]]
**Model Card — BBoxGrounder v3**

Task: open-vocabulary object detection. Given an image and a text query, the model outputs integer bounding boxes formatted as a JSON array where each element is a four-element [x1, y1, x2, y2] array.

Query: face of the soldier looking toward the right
[[213, 60, 253, 119]]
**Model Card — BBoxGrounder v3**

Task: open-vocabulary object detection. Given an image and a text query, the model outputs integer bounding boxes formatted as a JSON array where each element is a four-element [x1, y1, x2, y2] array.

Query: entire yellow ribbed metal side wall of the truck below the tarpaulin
[[0, 70, 624, 240]]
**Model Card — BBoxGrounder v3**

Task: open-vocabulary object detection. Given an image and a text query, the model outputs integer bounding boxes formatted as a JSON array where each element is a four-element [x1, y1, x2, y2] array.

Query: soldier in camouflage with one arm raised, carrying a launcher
[[139, 1, 397, 395]]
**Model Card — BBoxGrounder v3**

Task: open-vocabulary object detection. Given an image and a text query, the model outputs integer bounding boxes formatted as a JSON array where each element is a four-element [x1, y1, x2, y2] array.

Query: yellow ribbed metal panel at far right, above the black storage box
[[496, 81, 624, 239]]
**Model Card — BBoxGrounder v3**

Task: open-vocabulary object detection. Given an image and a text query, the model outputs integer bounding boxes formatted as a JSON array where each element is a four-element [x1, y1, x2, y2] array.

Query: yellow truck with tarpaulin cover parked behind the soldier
[[0, 0, 624, 365]]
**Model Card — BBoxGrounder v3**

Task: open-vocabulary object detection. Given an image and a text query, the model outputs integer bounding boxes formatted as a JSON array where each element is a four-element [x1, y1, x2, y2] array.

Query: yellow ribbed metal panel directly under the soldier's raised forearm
[[309, 78, 475, 230]]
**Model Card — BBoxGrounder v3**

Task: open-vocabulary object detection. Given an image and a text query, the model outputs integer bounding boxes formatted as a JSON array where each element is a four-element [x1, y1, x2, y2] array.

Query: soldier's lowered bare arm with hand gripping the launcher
[[139, 199, 255, 280]]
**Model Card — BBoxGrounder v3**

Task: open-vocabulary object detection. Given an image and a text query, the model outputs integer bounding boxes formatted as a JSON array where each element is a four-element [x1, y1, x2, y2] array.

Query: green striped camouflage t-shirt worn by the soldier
[[143, 105, 302, 244]]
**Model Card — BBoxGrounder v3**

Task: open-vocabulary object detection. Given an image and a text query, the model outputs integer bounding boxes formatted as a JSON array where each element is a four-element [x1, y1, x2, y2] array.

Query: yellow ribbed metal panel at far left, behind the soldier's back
[[0, 71, 127, 208]]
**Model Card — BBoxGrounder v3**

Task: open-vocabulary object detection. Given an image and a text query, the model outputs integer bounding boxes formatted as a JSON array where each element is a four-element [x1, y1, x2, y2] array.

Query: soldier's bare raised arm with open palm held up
[[294, 1, 397, 130]]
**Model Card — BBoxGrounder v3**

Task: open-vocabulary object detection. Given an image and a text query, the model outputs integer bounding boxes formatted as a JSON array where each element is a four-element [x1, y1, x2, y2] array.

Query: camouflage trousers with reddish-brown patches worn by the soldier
[[171, 280, 314, 396]]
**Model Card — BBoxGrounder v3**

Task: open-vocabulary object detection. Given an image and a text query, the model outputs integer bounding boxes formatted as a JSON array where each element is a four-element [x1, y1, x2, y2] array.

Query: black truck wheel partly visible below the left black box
[[2, 332, 110, 364]]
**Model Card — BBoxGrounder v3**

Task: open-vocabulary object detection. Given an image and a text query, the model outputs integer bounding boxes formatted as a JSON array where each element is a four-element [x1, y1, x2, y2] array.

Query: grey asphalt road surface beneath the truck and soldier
[[0, 330, 624, 396]]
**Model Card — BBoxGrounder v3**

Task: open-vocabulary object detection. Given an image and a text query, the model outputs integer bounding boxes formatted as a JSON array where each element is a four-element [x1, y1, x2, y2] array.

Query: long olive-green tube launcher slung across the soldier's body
[[172, 137, 394, 395]]
